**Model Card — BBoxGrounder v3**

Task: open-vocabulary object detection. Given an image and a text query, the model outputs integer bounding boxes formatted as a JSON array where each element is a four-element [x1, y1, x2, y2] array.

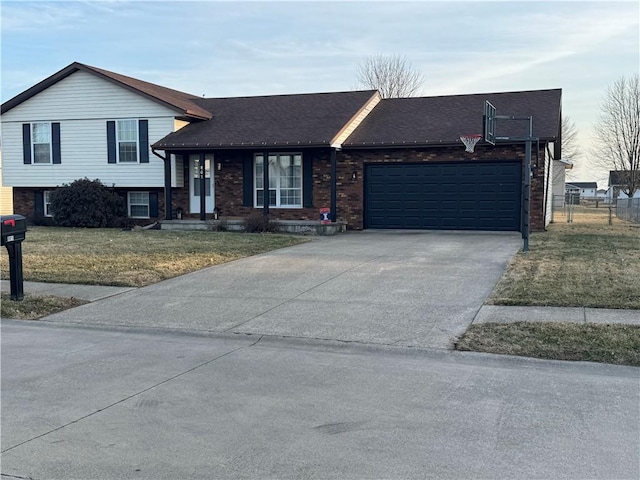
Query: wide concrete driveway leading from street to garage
[[45, 231, 521, 348]]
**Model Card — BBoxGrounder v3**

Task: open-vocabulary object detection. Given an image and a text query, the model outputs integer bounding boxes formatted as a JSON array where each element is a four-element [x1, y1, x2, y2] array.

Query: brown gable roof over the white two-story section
[[2, 62, 211, 119]]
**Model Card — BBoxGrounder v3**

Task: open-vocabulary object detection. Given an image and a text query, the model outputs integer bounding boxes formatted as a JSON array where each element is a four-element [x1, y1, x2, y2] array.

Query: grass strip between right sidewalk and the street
[[455, 322, 640, 366]]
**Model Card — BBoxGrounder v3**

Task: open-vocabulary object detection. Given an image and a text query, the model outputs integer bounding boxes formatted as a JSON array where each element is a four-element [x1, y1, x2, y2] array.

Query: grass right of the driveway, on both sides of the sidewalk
[[455, 206, 640, 366]]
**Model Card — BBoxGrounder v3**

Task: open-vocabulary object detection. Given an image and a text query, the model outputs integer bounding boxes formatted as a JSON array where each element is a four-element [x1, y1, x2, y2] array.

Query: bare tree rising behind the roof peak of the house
[[356, 55, 424, 98]]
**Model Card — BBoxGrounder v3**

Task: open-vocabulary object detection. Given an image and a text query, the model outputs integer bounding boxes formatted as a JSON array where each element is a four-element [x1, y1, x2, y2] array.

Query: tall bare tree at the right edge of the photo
[[594, 74, 640, 198]]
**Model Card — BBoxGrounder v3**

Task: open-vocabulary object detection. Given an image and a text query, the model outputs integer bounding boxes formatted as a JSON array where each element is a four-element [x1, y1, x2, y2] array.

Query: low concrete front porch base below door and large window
[[160, 217, 347, 235]]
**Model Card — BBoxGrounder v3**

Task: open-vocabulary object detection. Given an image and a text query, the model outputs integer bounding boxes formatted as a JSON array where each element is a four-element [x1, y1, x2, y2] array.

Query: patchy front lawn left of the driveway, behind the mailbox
[[0, 227, 308, 287]]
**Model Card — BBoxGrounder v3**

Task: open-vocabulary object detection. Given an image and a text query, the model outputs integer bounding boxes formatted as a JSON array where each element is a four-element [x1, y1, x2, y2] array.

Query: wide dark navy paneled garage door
[[364, 161, 522, 231]]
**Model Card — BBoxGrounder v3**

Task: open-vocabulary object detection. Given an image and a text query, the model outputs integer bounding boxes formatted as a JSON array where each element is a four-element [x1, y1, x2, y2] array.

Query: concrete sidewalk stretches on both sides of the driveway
[[2, 280, 640, 325]]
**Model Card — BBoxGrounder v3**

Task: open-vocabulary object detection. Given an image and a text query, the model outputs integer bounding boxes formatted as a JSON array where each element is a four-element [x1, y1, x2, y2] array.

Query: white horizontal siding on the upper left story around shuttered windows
[[2, 72, 178, 188]]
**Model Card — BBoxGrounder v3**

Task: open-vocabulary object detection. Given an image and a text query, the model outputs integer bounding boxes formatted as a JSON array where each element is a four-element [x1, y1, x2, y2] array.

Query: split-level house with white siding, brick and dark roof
[[1, 63, 564, 231]]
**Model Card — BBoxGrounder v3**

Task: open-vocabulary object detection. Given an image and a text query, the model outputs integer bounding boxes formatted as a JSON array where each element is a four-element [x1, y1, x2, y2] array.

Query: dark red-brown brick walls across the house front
[[13, 144, 545, 231]]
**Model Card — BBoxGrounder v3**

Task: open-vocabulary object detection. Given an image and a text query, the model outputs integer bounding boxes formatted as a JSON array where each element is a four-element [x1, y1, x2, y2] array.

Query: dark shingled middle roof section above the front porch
[[153, 90, 377, 150]]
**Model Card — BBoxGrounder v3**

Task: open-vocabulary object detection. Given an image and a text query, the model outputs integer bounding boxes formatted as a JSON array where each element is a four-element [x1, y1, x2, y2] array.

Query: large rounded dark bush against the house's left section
[[51, 178, 127, 228]]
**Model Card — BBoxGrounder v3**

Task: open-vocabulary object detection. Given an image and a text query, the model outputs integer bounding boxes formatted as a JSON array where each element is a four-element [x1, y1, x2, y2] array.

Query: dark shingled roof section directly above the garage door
[[343, 89, 562, 147]]
